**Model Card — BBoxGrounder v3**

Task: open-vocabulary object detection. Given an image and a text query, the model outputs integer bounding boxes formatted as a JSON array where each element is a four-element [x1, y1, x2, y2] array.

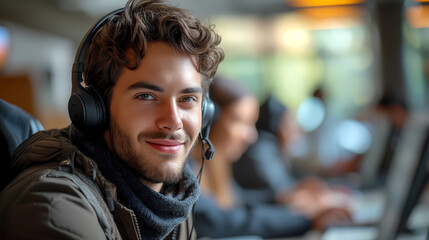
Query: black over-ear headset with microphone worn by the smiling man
[[68, 8, 215, 159]]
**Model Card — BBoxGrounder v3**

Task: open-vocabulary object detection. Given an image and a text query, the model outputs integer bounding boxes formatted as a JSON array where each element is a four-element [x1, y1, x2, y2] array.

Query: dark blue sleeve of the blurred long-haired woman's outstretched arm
[[194, 194, 311, 238]]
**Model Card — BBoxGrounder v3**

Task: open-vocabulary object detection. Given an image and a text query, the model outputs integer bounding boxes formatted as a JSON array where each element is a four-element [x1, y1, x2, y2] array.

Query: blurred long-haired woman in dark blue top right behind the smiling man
[[191, 78, 350, 238]]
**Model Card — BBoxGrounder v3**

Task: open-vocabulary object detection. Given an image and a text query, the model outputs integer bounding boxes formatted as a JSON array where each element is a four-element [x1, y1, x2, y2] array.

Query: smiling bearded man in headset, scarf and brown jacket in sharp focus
[[0, 0, 224, 239]]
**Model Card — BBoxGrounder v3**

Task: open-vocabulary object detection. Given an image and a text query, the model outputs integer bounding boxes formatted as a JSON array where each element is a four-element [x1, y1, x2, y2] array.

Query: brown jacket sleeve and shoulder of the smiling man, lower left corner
[[0, 165, 106, 239]]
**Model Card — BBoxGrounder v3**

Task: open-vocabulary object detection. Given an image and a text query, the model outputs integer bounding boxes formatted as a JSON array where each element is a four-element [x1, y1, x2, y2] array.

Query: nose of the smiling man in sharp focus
[[156, 100, 183, 132]]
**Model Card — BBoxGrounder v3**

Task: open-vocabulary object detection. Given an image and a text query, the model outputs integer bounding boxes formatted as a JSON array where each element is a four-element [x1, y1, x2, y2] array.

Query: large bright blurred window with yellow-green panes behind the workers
[[213, 1, 374, 116]]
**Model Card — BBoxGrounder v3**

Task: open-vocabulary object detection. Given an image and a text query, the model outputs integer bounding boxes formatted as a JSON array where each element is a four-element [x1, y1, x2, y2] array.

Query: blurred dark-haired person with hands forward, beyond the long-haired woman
[[233, 96, 350, 219]]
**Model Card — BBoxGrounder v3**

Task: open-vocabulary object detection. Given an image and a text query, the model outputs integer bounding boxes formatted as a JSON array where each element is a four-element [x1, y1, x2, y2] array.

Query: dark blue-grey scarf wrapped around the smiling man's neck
[[70, 126, 200, 239]]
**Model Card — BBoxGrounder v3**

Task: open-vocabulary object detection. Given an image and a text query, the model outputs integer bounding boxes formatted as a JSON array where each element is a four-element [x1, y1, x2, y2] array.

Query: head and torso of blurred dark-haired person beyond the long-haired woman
[[233, 96, 297, 193]]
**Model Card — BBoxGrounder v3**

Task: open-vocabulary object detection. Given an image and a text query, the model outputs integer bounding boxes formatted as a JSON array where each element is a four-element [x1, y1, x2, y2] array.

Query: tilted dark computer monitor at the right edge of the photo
[[377, 115, 429, 239]]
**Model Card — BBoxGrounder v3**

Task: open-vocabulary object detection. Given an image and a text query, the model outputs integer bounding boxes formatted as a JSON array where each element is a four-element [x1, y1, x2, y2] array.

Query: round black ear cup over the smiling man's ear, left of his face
[[68, 87, 108, 130]]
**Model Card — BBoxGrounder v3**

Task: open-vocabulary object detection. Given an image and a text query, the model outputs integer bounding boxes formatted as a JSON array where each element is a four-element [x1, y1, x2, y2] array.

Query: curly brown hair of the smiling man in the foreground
[[84, 0, 224, 105]]
